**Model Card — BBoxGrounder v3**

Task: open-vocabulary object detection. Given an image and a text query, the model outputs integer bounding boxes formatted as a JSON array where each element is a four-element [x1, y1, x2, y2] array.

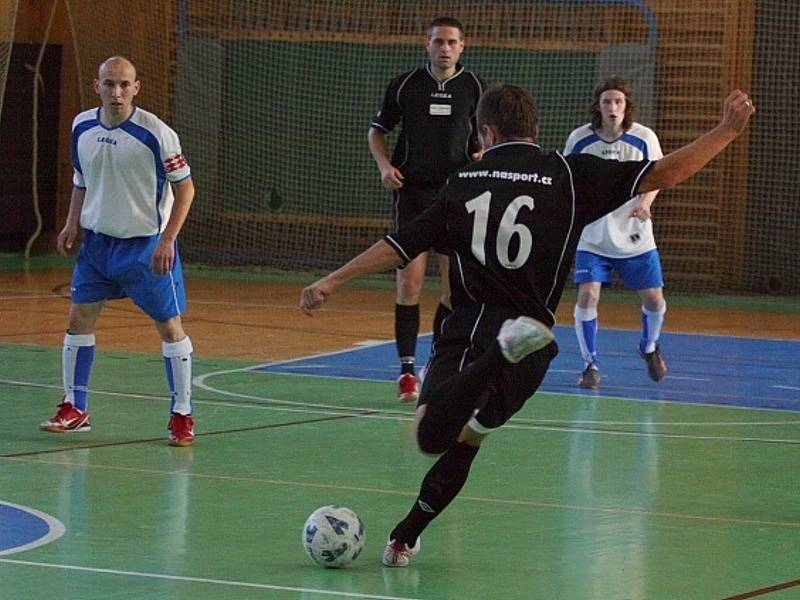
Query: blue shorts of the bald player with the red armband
[[72, 231, 186, 321]]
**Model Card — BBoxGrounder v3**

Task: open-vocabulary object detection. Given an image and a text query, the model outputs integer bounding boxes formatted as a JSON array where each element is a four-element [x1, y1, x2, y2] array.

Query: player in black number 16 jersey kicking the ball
[[300, 85, 755, 567]]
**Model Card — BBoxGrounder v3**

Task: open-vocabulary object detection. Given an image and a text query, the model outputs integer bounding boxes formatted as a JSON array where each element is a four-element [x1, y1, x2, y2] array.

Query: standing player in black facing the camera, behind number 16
[[368, 17, 485, 402]]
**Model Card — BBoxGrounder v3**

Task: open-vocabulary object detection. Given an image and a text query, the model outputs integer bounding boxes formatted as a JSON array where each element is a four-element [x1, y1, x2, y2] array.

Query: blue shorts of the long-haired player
[[575, 250, 664, 290]]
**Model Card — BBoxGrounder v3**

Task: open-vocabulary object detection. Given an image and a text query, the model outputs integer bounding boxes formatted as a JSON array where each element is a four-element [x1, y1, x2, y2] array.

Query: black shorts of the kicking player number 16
[[418, 305, 558, 433]]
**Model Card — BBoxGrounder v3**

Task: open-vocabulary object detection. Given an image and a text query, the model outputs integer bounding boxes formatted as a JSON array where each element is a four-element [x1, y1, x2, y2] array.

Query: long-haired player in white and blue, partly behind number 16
[[564, 77, 667, 389]]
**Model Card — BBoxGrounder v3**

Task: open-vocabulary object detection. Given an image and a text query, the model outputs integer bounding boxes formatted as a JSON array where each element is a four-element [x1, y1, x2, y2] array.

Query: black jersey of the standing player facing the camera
[[371, 64, 485, 184]]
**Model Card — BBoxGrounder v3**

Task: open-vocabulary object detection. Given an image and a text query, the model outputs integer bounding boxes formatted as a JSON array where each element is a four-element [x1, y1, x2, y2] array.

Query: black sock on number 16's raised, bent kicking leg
[[417, 341, 508, 454]]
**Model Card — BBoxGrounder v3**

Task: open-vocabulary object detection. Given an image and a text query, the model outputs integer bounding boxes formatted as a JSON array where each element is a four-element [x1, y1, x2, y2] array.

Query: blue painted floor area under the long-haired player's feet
[[260, 326, 800, 411]]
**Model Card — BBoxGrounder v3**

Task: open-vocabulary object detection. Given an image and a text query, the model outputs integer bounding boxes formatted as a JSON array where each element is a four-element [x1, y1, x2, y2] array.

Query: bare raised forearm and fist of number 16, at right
[[636, 90, 756, 193]]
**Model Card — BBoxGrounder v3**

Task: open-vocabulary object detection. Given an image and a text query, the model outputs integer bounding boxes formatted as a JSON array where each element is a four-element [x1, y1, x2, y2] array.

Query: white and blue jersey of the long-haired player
[[564, 123, 663, 258]]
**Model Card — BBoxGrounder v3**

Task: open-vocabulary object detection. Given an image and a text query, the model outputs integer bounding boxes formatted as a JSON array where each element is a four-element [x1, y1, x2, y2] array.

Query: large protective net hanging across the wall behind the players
[[43, 0, 800, 295]]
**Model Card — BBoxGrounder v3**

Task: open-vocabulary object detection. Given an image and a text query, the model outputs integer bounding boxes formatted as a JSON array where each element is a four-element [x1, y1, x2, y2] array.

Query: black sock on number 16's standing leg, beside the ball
[[389, 442, 478, 547]]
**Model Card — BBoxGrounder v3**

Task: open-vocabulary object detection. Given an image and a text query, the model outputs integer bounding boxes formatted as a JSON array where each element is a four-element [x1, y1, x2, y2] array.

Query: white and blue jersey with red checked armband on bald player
[[72, 107, 190, 238]]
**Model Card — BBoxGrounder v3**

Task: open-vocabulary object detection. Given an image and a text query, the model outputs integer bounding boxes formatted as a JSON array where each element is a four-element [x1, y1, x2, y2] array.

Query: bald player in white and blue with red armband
[[40, 56, 194, 446]]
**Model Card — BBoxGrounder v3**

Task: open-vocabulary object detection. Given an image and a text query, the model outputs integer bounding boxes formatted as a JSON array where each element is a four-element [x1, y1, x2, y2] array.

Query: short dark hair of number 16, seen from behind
[[476, 84, 539, 140]]
